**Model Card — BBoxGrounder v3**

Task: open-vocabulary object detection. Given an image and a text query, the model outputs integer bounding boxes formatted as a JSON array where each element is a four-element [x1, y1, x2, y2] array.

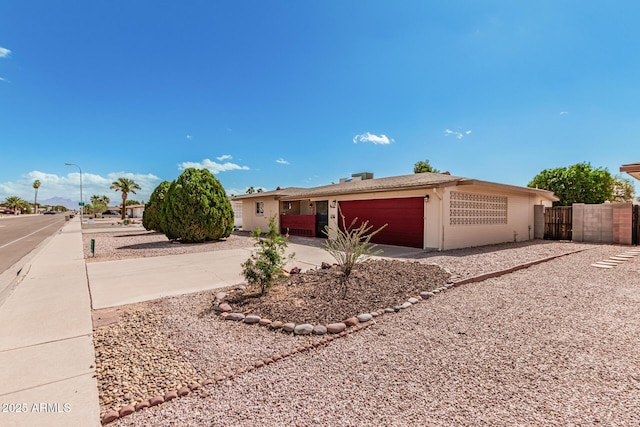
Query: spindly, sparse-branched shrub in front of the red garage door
[[323, 215, 388, 298]]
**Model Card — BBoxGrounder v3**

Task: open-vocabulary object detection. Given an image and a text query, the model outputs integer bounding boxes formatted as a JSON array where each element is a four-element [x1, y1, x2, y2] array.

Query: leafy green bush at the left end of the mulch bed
[[242, 216, 294, 295]]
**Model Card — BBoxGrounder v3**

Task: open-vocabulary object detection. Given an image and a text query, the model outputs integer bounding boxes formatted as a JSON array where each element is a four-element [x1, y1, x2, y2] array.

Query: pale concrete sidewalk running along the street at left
[[0, 219, 100, 427]]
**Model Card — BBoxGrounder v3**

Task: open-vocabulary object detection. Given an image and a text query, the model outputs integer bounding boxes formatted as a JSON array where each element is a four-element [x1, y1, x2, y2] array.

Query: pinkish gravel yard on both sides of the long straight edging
[[100, 242, 640, 426]]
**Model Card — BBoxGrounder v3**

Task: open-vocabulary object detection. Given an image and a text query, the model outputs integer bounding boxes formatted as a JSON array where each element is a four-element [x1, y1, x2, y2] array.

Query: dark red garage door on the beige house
[[340, 197, 424, 248]]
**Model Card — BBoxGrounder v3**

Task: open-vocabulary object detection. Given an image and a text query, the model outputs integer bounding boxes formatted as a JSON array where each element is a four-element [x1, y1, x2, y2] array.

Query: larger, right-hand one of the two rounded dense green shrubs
[[161, 168, 233, 243]]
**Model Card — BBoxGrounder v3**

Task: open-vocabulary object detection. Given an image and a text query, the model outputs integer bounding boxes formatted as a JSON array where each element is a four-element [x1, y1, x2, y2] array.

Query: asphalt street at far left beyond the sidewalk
[[0, 214, 65, 274]]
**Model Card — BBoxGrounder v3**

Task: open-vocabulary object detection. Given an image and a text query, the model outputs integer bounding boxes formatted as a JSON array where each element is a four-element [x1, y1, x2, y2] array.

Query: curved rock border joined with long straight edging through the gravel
[[100, 248, 591, 425]]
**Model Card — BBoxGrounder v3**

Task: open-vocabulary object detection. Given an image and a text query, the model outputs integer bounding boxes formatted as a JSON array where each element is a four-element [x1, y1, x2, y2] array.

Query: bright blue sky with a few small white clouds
[[0, 0, 640, 206]]
